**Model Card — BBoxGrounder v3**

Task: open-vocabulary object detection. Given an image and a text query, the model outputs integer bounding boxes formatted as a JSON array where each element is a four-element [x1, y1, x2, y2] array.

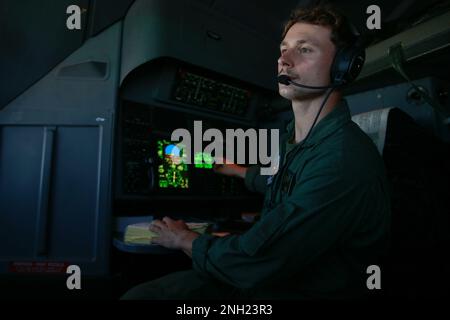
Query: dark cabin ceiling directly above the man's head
[[206, 0, 450, 45]]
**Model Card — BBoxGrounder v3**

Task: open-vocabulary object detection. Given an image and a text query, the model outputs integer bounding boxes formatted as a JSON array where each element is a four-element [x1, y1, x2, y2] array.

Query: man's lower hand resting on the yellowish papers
[[150, 217, 199, 256]]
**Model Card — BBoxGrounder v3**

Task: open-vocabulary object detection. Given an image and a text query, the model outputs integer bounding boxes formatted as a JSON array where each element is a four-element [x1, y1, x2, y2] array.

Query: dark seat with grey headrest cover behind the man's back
[[352, 108, 450, 298]]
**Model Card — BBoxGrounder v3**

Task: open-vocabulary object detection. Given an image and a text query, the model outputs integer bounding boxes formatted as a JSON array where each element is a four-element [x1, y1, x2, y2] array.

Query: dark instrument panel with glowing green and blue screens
[[117, 101, 250, 197]]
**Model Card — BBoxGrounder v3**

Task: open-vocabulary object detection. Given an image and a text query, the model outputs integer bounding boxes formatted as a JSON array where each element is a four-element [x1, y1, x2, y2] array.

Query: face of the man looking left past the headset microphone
[[278, 23, 335, 100]]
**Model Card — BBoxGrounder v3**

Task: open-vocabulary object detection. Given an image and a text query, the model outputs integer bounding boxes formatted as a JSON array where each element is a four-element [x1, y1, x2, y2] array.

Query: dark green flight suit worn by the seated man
[[122, 101, 390, 299]]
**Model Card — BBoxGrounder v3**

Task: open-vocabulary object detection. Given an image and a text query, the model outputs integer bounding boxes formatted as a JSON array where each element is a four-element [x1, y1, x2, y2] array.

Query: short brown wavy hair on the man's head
[[281, 6, 356, 48]]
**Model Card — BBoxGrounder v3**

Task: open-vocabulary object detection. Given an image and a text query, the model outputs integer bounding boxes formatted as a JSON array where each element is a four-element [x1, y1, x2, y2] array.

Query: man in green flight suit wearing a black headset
[[123, 7, 390, 299]]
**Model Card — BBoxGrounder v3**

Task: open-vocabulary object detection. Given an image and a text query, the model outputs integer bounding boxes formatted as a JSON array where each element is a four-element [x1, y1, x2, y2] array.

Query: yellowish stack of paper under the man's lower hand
[[124, 222, 210, 244]]
